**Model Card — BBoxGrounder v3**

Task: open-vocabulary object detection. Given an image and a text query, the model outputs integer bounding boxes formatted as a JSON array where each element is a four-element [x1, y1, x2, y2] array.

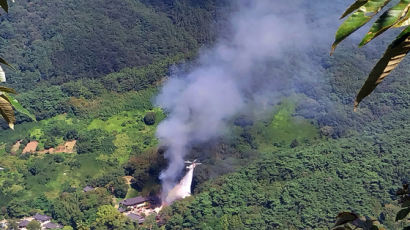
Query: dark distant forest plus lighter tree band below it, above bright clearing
[[0, 1, 226, 121]]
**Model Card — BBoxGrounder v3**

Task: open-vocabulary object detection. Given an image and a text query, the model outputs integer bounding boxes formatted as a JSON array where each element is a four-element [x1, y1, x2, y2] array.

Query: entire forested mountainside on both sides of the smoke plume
[[0, 0, 410, 229]]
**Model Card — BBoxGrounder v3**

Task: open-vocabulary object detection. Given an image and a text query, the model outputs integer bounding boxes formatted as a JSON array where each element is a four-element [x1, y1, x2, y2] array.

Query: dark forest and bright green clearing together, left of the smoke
[[0, 1, 223, 229]]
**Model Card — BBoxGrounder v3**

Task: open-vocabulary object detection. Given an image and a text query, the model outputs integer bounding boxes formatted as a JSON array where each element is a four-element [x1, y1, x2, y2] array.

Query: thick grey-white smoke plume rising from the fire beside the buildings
[[156, 0, 345, 202]]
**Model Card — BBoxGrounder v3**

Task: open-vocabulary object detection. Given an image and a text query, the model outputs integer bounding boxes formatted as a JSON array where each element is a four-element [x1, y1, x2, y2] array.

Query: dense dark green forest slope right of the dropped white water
[[166, 124, 408, 229]]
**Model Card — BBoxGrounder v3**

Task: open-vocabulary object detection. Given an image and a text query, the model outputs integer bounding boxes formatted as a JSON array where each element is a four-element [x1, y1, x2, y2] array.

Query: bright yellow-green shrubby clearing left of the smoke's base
[[0, 78, 165, 226]]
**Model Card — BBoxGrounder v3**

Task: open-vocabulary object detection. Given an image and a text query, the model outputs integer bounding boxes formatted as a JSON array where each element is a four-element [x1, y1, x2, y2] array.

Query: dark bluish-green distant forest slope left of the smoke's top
[[0, 0, 216, 90]]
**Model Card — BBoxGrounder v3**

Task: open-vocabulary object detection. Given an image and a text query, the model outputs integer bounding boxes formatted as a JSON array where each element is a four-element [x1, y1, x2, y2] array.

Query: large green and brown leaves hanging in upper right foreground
[[331, 0, 410, 109]]
